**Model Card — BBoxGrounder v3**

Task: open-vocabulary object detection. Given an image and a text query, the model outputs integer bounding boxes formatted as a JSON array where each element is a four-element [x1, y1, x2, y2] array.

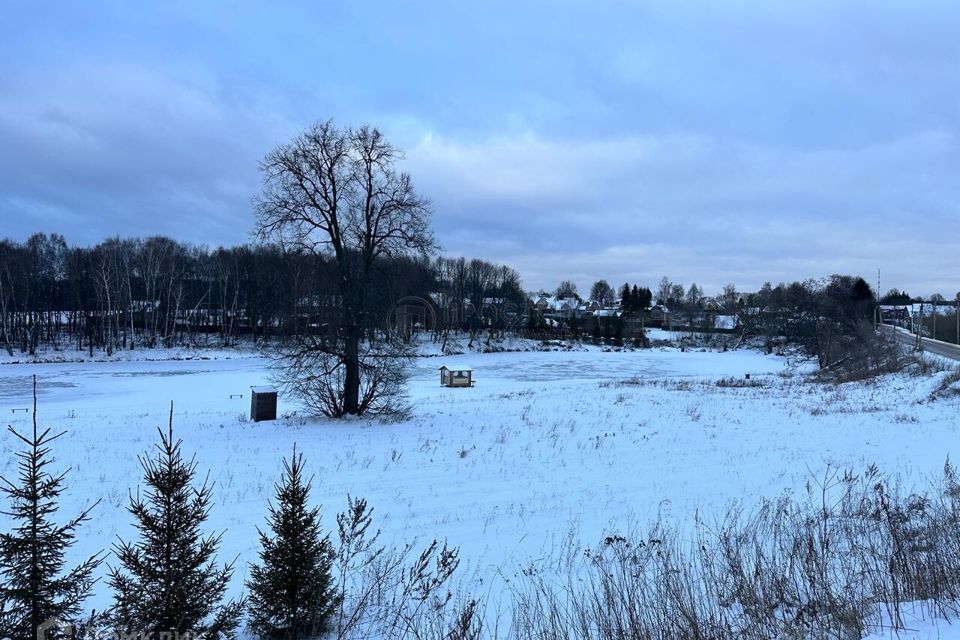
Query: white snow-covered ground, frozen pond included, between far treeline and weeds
[[0, 349, 960, 637]]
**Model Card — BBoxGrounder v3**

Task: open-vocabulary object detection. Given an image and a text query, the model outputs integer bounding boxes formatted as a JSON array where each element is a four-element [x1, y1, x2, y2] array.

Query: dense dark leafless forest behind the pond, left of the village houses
[[0, 234, 526, 355]]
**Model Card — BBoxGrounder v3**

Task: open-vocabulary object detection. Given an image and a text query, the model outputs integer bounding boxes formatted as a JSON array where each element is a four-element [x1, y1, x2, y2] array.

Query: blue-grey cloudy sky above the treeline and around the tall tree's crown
[[0, 0, 960, 298]]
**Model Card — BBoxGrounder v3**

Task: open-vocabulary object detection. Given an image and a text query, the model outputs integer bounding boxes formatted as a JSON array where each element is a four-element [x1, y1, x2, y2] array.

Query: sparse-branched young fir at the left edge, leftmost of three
[[0, 376, 103, 640]]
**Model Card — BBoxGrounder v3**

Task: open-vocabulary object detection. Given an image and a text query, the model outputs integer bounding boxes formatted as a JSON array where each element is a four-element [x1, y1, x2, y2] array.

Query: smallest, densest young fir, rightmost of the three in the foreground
[[247, 447, 340, 640]]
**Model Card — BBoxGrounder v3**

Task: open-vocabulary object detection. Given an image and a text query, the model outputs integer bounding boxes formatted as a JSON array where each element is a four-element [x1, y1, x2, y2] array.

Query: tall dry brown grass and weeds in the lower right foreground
[[510, 463, 960, 640]]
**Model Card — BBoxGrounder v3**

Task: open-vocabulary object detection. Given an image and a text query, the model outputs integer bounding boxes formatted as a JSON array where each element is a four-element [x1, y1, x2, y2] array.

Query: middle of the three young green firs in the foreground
[[109, 404, 243, 637]]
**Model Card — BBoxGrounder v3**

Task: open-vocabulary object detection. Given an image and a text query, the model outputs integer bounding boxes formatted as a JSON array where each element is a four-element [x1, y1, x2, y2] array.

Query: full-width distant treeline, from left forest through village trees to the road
[[0, 234, 960, 356]]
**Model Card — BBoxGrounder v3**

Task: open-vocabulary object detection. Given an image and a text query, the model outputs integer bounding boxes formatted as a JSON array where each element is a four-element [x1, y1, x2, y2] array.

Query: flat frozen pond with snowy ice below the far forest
[[0, 350, 785, 417]]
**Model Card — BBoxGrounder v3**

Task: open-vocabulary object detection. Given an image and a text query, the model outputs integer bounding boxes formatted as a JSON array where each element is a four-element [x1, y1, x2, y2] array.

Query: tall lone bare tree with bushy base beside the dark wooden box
[[255, 121, 434, 417]]
